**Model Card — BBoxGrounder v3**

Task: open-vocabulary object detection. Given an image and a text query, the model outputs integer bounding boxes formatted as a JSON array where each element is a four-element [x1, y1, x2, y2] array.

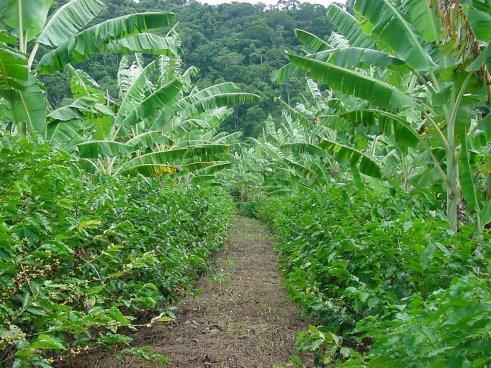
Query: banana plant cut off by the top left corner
[[0, 0, 180, 139]]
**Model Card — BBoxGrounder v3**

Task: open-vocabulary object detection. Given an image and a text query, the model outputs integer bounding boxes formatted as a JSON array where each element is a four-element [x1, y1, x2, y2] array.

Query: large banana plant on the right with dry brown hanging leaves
[[275, 0, 491, 231]]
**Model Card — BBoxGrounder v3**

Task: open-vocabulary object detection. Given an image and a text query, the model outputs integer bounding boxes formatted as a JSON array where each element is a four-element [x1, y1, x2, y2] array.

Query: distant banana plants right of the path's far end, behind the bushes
[[232, 75, 383, 198]]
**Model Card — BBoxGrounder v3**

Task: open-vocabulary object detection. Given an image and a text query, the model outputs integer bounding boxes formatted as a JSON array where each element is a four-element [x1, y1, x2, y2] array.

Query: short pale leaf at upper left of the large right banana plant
[[327, 4, 375, 48]]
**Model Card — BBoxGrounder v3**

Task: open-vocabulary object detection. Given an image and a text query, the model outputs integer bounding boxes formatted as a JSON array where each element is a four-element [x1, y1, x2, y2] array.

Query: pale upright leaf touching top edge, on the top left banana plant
[[37, 0, 104, 47]]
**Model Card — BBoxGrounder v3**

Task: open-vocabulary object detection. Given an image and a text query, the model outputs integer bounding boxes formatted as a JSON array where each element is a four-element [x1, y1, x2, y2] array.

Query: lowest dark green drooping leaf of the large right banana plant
[[339, 109, 420, 147]]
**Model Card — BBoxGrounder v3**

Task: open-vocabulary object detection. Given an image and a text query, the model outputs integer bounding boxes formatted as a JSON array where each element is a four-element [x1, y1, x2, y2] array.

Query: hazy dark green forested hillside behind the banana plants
[[45, 0, 331, 136]]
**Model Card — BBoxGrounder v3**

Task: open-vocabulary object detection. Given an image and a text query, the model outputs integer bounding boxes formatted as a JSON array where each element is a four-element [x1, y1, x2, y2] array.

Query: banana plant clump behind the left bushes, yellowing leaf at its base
[[48, 55, 258, 182]]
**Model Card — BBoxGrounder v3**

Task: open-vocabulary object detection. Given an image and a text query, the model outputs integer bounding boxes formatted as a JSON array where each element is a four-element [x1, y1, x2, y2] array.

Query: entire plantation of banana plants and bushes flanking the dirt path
[[0, 0, 491, 367]]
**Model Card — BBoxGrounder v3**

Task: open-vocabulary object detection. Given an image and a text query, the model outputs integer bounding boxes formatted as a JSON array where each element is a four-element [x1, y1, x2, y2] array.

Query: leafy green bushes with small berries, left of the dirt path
[[0, 138, 233, 367]]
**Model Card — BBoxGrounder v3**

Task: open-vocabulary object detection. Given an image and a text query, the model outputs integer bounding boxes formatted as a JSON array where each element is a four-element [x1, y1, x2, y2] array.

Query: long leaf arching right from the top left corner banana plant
[[37, 12, 175, 74]]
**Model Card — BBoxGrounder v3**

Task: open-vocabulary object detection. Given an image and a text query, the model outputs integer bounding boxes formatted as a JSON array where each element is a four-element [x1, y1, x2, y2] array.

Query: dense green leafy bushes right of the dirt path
[[261, 185, 490, 367]]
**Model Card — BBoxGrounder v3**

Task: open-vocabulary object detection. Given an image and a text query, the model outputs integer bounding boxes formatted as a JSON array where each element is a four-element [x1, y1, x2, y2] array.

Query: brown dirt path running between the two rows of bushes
[[67, 217, 305, 368]]
